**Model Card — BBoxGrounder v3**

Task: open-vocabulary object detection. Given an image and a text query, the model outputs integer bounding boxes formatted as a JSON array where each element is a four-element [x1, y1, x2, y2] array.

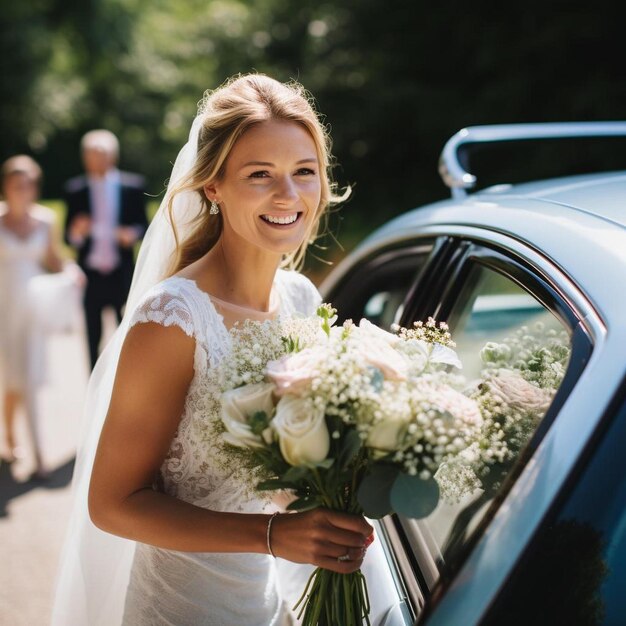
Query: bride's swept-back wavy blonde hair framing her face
[[168, 74, 350, 274]]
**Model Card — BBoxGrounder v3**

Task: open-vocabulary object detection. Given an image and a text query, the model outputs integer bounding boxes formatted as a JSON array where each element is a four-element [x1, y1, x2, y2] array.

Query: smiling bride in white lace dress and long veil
[[53, 74, 372, 626]]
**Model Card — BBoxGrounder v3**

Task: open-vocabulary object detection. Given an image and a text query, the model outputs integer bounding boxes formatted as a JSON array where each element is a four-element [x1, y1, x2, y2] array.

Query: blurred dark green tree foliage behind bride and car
[[0, 0, 626, 266]]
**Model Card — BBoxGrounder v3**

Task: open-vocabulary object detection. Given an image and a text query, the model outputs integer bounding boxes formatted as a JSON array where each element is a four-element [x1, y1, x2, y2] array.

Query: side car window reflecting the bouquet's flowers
[[399, 263, 571, 589]]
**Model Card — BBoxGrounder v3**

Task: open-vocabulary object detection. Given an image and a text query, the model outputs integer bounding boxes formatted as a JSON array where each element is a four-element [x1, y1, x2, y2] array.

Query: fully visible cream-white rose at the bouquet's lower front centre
[[272, 395, 330, 466]]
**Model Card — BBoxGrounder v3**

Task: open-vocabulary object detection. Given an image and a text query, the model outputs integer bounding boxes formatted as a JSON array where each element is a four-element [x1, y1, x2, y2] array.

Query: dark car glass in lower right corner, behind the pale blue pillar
[[485, 388, 626, 626]]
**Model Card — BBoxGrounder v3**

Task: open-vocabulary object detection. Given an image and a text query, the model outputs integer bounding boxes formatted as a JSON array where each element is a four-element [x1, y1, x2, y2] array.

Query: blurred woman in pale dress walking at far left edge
[[0, 155, 62, 478]]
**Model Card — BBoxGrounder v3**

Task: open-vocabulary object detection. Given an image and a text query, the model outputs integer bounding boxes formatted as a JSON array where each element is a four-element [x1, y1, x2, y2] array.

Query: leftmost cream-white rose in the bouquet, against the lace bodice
[[222, 383, 276, 448]]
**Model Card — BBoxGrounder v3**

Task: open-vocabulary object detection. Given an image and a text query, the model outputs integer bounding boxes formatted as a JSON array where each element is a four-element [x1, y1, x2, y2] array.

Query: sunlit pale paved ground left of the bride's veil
[[0, 320, 112, 626]]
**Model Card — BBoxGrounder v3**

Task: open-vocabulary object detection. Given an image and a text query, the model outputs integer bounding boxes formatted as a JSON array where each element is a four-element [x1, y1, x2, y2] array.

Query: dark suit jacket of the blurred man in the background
[[65, 172, 148, 291]]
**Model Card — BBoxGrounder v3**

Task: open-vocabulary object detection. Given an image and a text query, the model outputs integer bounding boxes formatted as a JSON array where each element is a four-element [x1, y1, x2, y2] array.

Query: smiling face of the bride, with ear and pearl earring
[[205, 120, 321, 255]]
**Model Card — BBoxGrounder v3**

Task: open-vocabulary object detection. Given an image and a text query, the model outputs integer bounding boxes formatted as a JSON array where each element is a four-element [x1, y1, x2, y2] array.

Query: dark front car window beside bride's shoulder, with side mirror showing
[[330, 241, 433, 330]]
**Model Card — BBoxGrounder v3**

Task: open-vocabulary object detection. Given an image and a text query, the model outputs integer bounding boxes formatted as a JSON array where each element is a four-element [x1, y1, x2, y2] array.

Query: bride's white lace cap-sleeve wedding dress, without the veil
[[123, 270, 320, 626]]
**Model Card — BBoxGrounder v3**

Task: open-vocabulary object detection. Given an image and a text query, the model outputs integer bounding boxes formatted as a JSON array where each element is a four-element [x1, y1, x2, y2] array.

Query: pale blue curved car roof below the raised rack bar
[[321, 171, 626, 324]]
